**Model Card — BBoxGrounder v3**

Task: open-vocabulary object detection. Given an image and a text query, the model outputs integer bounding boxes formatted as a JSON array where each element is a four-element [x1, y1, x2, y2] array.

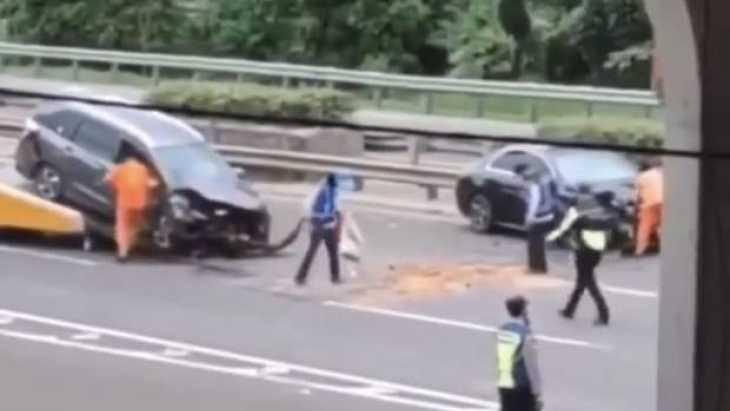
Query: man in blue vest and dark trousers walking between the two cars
[[296, 174, 341, 286]]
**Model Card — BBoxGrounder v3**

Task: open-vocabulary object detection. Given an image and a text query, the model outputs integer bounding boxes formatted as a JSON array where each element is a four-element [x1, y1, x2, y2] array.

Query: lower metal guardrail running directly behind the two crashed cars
[[0, 119, 460, 200]]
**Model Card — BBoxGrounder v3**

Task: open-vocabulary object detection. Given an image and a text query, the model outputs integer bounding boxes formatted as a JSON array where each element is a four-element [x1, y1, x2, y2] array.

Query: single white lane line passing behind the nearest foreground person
[[324, 301, 611, 351]]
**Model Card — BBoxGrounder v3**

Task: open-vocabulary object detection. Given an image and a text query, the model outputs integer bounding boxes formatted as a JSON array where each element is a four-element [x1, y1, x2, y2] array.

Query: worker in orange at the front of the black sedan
[[635, 160, 664, 255]]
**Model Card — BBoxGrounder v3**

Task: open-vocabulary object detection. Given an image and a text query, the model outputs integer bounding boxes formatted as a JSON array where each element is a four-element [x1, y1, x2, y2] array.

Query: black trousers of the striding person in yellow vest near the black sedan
[[565, 248, 609, 321]]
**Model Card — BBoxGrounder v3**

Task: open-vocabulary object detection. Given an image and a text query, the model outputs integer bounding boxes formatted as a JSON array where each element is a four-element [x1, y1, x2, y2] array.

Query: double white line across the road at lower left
[[0, 309, 499, 411]]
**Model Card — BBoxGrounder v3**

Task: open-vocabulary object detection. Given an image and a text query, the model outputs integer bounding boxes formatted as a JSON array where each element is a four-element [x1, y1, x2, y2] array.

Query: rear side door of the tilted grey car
[[68, 117, 121, 217]]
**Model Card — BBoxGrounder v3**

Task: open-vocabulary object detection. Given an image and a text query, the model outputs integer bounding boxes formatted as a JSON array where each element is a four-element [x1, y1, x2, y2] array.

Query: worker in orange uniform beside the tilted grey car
[[106, 157, 159, 262]]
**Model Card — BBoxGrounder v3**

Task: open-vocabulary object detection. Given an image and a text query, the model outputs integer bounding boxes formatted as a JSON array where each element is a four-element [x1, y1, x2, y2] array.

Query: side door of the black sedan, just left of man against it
[[486, 150, 527, 225]]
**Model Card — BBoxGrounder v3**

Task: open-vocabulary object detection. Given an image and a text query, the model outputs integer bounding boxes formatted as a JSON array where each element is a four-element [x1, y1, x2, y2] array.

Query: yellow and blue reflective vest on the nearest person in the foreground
[[497, 322, 530, 389]]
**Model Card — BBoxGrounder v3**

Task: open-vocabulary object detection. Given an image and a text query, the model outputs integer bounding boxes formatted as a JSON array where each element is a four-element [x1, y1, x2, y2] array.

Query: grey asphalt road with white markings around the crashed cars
[[0, 185, 658, 411]]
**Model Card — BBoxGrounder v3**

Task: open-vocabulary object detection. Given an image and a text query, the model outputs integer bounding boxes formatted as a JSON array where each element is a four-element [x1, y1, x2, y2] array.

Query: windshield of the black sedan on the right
[[554, 151, 637, 184]]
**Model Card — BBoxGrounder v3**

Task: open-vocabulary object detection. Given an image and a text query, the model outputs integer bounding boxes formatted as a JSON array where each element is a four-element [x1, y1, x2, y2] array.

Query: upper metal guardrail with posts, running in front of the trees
[[0, 42, 660, 122]]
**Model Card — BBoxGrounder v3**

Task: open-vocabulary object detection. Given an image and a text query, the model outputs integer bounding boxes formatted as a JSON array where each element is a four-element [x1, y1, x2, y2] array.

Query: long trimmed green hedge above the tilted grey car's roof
[[145, 81, 355, 120]]
